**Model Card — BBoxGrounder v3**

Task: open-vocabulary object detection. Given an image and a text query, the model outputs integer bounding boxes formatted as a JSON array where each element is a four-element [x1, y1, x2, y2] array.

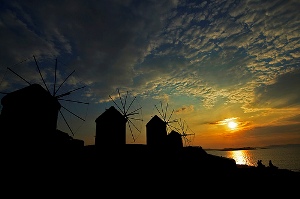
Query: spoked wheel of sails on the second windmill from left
[[109, 88, 143, 142]]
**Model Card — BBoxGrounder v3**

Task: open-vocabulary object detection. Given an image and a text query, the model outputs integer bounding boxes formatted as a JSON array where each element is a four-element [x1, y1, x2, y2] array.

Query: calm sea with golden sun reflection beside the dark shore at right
[[206, 145, 300, 172]]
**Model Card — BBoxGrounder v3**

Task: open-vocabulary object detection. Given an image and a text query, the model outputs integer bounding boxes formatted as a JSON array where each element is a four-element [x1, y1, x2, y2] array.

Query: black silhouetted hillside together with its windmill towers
[[0, 81, 300, 196]]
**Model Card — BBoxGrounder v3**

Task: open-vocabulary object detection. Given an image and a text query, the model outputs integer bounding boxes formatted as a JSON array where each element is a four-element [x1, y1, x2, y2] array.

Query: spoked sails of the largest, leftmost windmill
[[0, 56, 89, 136]]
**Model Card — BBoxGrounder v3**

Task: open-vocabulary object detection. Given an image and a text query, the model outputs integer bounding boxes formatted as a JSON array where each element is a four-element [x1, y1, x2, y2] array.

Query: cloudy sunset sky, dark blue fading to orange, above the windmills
[[0, 0, 300, 148]]
